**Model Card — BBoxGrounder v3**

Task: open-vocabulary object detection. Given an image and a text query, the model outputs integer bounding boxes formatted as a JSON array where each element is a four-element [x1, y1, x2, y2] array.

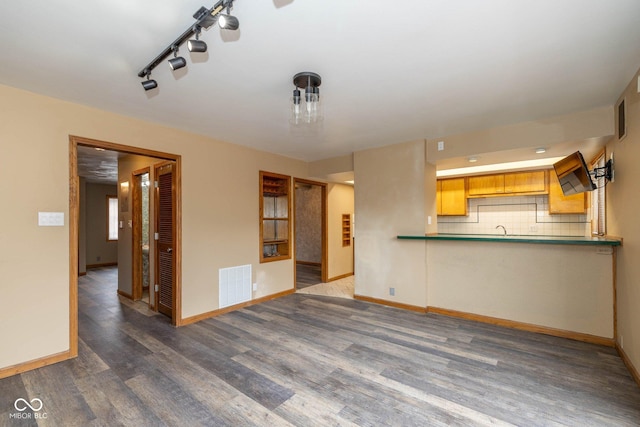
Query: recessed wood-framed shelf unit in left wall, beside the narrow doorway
[[260, 171, 291, 262]]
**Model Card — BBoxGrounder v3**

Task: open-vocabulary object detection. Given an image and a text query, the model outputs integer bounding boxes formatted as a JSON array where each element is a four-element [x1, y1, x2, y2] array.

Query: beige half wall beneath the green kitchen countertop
[[427, 241, 613, 338]]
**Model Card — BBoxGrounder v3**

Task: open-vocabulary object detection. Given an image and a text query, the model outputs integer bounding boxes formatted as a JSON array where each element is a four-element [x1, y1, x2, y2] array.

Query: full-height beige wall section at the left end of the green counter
[[354, 141, 427, 307]]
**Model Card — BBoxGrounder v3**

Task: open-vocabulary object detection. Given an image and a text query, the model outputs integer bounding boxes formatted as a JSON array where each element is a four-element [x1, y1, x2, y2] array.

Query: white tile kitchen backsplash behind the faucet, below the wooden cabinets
[[438, 195, 591, 236]]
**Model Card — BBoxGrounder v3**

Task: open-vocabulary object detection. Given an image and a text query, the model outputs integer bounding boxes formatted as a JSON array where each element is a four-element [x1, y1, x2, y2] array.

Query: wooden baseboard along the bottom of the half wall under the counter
[[427, 307, 615, 347]]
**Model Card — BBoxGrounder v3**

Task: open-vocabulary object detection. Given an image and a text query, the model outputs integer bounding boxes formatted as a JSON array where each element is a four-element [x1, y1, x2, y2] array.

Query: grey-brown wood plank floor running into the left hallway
[[0, 269, 640, 426]]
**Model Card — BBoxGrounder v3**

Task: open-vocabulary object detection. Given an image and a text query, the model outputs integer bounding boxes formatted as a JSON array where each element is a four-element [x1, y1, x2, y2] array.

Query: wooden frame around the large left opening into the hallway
[[69, 135, 183, 357]]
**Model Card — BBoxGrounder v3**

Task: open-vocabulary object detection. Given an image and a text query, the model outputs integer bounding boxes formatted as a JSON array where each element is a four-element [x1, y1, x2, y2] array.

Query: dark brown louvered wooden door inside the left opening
[[156, 165, 175, 317]]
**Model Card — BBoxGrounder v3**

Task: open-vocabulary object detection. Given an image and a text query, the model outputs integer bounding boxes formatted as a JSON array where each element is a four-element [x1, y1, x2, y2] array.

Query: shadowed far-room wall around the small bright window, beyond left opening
[[80, 183, 118, 265]]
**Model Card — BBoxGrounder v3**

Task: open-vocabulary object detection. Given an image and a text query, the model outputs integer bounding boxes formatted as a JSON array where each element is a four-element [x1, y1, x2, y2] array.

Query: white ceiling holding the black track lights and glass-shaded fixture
[[0, 0, 640, 166]]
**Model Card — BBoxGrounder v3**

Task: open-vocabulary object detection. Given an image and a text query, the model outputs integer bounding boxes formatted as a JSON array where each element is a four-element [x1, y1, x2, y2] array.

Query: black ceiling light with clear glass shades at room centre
[[290, 71, 323, 125]]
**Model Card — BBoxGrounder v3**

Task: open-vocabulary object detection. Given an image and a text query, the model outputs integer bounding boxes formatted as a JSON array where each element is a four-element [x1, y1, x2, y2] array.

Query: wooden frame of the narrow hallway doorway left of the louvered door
[[131, 166, 152, 307]]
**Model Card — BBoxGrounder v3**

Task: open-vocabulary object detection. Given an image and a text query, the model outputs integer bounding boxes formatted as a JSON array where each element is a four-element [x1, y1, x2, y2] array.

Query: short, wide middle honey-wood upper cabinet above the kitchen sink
[[467, 170, 548, 197]]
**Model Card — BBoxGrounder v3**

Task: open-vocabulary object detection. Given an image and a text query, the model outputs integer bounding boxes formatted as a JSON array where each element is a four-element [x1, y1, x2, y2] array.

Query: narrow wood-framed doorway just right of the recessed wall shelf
[[293, 178, 327, 289]]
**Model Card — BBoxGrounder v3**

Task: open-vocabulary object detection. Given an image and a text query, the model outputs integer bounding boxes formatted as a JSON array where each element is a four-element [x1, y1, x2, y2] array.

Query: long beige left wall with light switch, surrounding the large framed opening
[[0, 86, 307, 368]]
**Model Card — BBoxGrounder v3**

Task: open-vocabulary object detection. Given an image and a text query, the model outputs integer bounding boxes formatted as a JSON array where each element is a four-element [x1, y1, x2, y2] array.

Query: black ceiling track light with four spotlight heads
[[138, 0, 239, 90]]
